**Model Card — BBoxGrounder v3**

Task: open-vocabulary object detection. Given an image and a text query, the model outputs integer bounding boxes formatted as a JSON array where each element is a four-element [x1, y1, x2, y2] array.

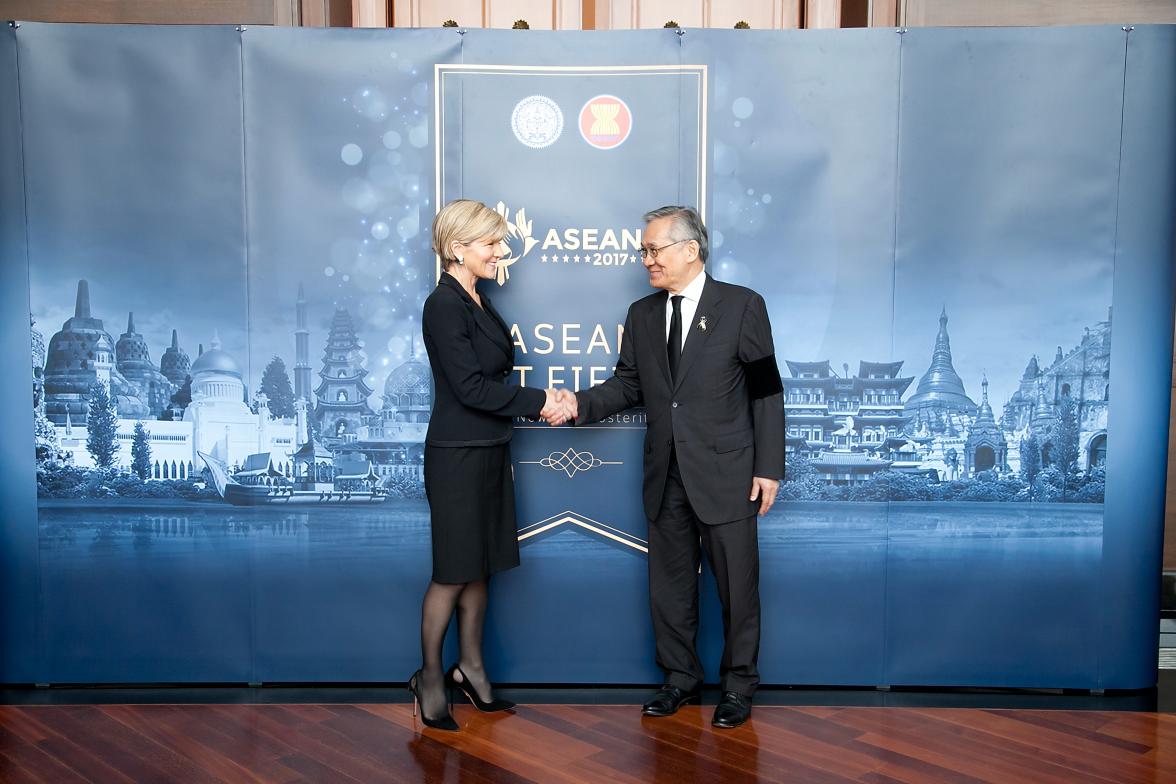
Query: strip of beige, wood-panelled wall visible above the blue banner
[[13, 0, 1161, 29]]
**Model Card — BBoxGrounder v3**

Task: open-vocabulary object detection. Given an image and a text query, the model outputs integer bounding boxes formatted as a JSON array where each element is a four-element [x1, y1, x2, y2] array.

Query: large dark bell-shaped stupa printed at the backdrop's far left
[[45, 281, 151, 425]]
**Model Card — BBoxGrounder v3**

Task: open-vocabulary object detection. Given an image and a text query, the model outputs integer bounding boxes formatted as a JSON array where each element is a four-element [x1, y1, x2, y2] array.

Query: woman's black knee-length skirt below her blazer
[[425, 443, 519, 584]]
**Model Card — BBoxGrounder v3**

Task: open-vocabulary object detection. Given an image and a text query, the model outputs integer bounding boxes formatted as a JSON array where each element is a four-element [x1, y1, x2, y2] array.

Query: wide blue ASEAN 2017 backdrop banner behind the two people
[[0, 24, 1176, 689]]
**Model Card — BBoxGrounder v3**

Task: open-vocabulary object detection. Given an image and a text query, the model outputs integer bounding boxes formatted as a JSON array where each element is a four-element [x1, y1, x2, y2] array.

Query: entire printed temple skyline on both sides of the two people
[[32, 280, 1111, 503]]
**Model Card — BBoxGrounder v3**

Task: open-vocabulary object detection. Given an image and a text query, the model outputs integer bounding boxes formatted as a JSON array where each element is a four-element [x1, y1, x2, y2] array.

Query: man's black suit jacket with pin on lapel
[[576, 277, 784, 524]]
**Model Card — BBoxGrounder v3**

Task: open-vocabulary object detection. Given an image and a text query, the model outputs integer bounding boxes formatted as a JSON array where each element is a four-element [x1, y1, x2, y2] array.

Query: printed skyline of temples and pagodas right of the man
[[782, 309, 1111, 502]]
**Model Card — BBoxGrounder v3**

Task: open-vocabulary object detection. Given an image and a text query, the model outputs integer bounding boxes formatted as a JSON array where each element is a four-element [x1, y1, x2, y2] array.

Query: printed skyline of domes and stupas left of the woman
[[32, 280, 433, 500]]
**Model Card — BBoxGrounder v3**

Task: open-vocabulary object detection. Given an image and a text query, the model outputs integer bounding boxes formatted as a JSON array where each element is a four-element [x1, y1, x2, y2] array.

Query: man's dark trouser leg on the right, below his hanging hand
[[701, 516, 760, 698]]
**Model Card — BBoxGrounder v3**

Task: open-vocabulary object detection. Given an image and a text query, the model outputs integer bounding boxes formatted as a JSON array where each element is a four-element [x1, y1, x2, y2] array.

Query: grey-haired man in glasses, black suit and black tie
[[557, 207, 784, 728]]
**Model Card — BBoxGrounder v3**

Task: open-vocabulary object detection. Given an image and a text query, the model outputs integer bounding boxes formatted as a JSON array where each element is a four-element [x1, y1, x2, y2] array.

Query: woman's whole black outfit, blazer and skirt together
[[421, 273, 547, 583]]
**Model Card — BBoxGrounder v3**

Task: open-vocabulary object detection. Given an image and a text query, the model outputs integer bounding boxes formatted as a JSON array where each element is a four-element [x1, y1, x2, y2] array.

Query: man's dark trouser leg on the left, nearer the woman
[[649, 461, 703, 691]]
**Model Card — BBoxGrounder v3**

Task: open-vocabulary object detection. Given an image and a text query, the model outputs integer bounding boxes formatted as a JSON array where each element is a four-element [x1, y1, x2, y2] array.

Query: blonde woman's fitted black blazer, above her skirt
[[421, 273, 547, 447]]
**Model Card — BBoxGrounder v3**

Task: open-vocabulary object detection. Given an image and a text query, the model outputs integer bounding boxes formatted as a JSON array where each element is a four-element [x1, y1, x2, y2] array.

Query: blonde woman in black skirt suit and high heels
[[408, 199, 564, 730]]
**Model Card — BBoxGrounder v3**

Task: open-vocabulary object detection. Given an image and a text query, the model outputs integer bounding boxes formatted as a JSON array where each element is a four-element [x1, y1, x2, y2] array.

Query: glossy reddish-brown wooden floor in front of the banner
[[0, 704, 1176, 784]]
